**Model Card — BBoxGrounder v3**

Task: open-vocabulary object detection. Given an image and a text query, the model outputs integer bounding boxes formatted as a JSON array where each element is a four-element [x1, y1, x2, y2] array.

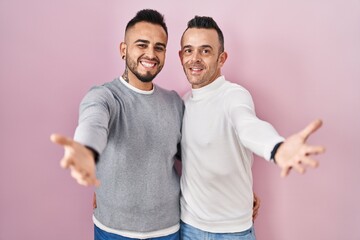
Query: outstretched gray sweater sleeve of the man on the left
[[74, 86, 114, 154]]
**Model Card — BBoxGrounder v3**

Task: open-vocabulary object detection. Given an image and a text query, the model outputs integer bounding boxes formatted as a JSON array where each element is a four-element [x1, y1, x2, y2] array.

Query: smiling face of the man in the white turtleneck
[[179, 28, 227, 89]]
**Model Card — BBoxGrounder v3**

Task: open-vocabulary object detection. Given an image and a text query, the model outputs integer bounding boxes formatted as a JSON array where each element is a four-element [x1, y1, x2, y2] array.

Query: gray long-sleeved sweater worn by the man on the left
[[75, 78, 184, 232]]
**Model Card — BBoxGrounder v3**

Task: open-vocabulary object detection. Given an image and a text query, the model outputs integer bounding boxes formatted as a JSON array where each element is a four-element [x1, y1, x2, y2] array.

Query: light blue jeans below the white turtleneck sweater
[[180, 222, 256, 240]]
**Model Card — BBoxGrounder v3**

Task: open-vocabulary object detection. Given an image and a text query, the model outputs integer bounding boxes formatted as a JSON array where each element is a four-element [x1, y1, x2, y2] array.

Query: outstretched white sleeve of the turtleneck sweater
[[224, 88, 284, 160]]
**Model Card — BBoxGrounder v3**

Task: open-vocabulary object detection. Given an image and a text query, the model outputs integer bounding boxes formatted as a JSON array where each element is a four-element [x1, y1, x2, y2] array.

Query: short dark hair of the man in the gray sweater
[[125, 9, 168, 35]]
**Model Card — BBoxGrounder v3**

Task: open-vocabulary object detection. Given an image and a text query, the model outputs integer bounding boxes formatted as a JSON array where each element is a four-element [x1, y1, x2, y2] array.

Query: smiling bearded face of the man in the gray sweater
[[120, 22, 167, 86]]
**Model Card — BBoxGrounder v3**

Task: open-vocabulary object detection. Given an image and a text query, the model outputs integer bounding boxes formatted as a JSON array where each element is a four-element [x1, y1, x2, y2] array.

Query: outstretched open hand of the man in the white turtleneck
[[274, 120, 325, 177]]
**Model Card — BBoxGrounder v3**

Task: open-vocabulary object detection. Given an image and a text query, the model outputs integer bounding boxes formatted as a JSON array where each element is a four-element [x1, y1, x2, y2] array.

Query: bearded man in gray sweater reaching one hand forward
[[51, 9, 183, 240]]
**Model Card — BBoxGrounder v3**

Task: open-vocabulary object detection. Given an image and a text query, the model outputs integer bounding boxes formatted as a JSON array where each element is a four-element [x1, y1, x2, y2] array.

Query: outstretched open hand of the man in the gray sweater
[[50, 134, 100, 186]]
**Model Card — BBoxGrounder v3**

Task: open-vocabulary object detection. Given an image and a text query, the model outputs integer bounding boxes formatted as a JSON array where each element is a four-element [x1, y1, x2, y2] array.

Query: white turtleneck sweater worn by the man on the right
[[181, 76, 284, 233]]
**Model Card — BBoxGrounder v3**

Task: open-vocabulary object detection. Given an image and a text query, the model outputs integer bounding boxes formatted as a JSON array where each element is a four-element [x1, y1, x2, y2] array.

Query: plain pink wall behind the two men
[[0, 0, 360, 240]]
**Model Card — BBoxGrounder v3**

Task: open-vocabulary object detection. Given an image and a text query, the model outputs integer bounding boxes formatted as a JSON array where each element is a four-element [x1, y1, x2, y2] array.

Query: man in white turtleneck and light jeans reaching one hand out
[[179, 16, 324, 240]]
